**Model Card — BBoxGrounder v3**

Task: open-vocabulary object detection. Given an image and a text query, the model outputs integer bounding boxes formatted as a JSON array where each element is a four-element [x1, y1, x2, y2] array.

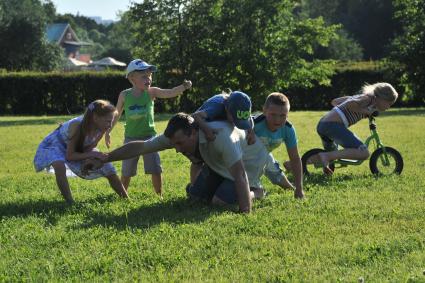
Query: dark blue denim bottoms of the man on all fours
[[186, 164, 255, 204]]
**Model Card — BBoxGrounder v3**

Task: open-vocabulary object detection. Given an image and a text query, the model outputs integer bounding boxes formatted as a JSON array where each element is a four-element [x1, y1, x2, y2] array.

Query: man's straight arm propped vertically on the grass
[[229, 159, 252, 213]]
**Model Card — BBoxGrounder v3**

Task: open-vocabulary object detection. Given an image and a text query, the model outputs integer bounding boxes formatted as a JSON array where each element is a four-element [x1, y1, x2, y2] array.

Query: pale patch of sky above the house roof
[[52, 0, 143, 21]]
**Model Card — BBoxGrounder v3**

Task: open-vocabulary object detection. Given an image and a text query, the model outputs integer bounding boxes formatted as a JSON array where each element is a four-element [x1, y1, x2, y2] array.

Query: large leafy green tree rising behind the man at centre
[[131, 0, 336, 110]]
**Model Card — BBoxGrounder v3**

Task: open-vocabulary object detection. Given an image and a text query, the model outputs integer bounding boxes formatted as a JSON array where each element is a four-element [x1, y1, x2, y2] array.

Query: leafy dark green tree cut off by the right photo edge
[[391, 0, 425, 105]]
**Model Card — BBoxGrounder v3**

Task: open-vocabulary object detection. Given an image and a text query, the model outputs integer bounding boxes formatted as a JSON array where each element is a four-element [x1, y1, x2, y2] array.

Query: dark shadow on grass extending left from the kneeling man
[[80, 198, 226, 230]]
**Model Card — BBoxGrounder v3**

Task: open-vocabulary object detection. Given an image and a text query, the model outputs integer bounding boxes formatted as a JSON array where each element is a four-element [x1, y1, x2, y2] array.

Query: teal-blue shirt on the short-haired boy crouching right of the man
[[254, 114, 297, 152]]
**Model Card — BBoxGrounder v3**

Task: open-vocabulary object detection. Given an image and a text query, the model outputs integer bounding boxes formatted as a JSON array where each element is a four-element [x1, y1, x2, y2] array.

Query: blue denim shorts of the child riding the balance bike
[[317, 122, 366, 151]]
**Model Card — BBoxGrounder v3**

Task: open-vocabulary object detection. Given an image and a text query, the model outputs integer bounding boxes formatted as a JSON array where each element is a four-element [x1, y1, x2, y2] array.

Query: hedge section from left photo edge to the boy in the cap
[[0, 72, 129, 115]]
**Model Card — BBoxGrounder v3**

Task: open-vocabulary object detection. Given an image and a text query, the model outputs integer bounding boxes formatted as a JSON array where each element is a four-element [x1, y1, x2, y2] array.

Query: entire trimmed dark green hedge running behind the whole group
[[0, 68, 402, 115]]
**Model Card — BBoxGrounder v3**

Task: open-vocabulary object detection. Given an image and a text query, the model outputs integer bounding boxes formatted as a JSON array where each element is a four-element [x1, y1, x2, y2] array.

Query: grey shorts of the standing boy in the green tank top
[[121, 136, 162, 177]]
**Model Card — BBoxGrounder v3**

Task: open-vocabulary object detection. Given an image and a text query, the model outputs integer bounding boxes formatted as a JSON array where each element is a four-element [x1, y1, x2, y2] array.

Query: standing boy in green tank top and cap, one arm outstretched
[[105, 59, 192, 197]]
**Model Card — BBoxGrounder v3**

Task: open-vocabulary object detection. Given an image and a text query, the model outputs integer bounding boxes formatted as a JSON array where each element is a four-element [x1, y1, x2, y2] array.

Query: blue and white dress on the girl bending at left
[[34, 116, 116, 180]]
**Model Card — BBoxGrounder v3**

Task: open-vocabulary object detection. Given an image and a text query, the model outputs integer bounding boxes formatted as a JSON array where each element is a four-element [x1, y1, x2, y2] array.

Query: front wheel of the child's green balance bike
[[369, 146, 404, 175]]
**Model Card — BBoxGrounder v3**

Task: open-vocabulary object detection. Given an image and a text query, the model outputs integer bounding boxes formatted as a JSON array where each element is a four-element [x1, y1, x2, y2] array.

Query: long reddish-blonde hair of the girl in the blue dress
[[76, 99, 117, 152]]
